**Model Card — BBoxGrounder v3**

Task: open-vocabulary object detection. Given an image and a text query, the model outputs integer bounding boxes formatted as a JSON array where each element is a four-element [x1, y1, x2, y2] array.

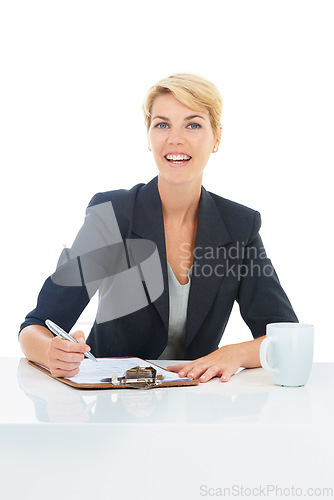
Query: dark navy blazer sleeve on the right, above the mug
[[237, 212, 298, 338]]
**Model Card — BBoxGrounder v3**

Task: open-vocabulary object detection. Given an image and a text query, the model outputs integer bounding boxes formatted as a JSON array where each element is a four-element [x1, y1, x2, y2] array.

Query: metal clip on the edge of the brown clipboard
[[101, 365, 162, 389]]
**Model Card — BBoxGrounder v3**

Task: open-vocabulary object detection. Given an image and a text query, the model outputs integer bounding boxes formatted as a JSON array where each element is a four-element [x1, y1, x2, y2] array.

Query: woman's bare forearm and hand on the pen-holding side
[[20, 325, 90, 377]]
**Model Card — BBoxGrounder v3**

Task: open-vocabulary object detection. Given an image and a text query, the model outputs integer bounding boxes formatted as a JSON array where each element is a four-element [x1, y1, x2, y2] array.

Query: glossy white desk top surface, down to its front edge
[[0, 358, 334, 427]]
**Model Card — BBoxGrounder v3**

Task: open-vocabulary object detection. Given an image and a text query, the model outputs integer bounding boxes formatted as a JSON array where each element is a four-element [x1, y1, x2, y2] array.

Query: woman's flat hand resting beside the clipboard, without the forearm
[[167, 344, 244, 382]]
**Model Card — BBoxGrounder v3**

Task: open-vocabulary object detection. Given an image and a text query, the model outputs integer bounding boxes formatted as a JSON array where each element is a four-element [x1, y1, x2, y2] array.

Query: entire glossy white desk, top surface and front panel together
[[0, 358, 334, 500]]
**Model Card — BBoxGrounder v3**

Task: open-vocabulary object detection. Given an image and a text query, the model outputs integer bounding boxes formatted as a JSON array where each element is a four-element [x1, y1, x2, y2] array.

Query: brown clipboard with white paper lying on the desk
[[29, 357, 199, 389]]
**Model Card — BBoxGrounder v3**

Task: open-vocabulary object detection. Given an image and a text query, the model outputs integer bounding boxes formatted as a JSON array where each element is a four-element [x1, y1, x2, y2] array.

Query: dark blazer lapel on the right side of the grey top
[[185, 187, 232, 348]]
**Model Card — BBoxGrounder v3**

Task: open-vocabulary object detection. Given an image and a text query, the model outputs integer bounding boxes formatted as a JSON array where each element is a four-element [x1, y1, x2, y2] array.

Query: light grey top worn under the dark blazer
[[159, 262, 192, 359]]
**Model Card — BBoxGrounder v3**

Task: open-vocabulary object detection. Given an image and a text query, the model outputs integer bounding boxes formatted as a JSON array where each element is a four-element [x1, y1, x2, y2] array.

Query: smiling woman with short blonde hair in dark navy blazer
[[20, 74, 298, 382]]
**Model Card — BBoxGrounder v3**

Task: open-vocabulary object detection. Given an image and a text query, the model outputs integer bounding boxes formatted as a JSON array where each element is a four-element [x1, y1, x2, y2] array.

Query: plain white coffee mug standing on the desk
[[260, 323, 314, 387]]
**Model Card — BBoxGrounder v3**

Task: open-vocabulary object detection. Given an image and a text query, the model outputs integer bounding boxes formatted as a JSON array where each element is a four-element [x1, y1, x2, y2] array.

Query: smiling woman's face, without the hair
[[148, 94, 217, 183]]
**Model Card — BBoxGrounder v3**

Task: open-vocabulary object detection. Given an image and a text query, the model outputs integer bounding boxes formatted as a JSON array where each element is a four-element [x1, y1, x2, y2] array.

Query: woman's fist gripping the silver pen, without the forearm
[[47, 330, 90, 377]]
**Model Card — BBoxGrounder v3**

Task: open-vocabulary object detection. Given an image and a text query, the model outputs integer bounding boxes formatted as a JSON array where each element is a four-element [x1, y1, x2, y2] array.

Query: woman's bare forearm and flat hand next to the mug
[[167, 335, 265, 382]]
